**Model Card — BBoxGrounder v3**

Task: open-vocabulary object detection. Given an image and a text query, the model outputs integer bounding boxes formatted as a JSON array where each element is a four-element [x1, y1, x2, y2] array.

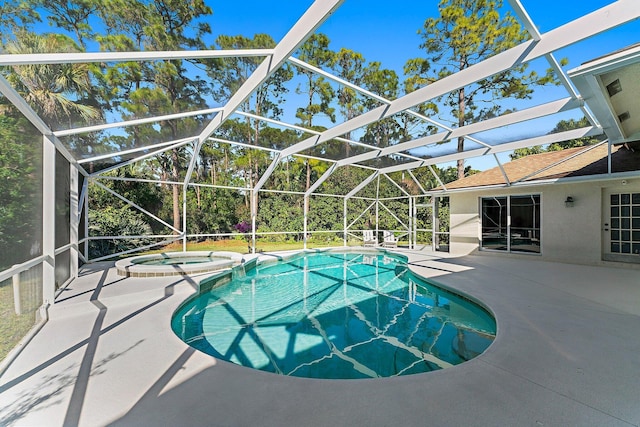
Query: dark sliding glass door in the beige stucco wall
[[481, 194, 540, 253]]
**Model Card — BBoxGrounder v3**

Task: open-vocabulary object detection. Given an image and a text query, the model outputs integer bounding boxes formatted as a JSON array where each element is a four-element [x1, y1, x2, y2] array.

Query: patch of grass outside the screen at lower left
[[0, 280, 36, 360]]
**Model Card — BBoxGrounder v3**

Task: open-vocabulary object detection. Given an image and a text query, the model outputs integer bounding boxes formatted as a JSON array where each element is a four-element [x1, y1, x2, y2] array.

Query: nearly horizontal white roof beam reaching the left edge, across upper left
[[0, 49, 274, 66]]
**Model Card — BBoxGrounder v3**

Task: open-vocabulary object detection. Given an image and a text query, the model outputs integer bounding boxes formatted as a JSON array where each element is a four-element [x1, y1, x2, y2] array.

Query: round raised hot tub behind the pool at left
[[116, 251, 244, 277]]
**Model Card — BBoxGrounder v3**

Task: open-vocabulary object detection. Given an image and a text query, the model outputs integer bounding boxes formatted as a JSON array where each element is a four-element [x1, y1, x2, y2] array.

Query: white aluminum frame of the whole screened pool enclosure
[[0, 0, 640, 304]]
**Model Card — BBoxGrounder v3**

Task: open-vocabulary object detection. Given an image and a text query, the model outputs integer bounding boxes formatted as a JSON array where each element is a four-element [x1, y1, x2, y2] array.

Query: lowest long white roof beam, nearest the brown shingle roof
[[380, 126, 602, 173]]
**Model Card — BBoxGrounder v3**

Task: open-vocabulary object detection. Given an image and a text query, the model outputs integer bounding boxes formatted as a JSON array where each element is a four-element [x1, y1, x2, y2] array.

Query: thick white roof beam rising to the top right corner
[[284, 0, 640, 161]]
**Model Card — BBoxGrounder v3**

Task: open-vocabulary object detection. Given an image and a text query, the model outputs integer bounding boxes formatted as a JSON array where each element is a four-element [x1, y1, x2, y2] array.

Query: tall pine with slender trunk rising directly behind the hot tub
[[98, 0, 212, 234]]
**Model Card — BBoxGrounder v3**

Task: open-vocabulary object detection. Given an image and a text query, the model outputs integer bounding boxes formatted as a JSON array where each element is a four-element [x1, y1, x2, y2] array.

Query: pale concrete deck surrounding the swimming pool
[[0, 250, 640, 426]]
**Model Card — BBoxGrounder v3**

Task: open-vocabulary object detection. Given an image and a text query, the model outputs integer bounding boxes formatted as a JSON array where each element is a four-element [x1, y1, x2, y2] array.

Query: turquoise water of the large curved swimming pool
[[172, 252, 496, 378]]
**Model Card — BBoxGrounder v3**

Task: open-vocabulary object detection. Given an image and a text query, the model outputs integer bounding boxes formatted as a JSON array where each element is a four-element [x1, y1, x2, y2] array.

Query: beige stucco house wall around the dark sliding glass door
[[450, 177, 640, 264]]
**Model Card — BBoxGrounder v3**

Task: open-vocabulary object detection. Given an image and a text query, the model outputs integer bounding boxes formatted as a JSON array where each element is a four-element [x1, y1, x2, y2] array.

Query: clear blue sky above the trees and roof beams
[[201, 0, 640, 169]]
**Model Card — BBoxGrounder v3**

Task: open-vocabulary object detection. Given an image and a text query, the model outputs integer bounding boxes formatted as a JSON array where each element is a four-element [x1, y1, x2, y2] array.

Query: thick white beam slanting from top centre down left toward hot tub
[[184, 0, 344, 189]]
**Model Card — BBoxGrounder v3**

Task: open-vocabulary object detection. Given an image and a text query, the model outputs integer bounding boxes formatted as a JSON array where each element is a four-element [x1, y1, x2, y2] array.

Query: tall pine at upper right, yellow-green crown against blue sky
[[405, 0, 554, 178]]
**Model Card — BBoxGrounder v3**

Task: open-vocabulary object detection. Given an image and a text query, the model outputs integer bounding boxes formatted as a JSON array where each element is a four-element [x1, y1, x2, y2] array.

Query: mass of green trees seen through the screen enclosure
[[0, 0, 580, 256]]
